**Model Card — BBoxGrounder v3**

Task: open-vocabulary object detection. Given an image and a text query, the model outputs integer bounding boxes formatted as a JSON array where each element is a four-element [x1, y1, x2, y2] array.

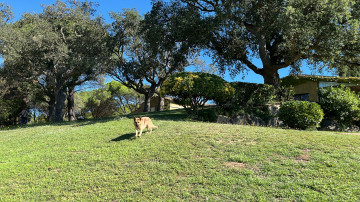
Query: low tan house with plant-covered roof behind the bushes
[[281, 75, 360, 102]]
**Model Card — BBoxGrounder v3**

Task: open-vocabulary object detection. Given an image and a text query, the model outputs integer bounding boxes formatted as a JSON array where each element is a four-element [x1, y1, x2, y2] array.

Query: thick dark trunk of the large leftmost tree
[[54, 82, 66, 122]]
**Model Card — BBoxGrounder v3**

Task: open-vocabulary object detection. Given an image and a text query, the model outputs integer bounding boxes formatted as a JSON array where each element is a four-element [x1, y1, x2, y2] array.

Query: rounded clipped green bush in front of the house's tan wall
[[279, 101, 324, 129]]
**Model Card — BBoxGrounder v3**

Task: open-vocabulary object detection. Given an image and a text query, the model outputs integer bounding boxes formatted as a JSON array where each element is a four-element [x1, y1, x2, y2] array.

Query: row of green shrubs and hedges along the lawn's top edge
[[161, 72, 360, 132]]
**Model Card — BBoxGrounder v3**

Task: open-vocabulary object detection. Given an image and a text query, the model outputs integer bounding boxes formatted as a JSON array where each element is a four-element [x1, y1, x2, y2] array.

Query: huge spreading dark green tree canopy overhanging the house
[[182, 0, 360, 86]]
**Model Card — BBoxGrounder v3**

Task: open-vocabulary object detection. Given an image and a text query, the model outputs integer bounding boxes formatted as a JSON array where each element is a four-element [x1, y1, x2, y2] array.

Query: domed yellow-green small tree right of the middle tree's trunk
[[161, 72, 234, 113]]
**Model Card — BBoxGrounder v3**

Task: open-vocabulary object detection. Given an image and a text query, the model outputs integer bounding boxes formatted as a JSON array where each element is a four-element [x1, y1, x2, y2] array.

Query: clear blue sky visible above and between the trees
[[0, 0, 331, 83]]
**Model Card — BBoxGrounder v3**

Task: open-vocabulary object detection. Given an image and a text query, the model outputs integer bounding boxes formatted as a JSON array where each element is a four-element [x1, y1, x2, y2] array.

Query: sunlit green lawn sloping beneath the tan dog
[[0, 111, 360, 201]]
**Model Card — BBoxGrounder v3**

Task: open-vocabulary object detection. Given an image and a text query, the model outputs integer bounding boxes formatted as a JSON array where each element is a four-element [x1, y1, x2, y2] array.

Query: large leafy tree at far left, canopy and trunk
[[0, 1, 108, 121]]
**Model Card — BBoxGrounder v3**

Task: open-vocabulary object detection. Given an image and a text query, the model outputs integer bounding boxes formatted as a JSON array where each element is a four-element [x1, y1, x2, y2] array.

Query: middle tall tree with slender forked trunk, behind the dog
[[109, 1, 200, 111]]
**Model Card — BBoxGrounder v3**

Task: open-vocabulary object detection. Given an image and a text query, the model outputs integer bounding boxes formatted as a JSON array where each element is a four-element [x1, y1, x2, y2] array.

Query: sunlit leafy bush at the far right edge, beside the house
[[319, 86, 360, 125]]
